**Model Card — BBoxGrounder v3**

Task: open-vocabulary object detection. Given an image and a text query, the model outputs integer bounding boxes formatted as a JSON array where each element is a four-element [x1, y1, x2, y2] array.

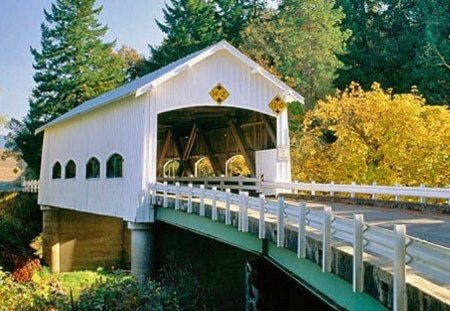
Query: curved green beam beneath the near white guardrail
[[156, 208, 387, 311]]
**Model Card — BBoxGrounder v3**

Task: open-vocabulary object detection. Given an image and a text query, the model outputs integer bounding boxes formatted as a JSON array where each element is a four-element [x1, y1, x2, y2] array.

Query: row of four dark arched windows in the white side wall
[[52, 153, 124, 179]]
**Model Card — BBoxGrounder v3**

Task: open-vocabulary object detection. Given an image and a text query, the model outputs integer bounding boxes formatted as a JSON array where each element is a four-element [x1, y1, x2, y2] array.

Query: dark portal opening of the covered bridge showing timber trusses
[[157, 106, 277, 179]]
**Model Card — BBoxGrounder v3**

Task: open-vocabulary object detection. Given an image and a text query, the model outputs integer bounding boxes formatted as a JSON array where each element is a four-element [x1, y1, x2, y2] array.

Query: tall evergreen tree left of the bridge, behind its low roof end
[[8, 0, 124, 176]]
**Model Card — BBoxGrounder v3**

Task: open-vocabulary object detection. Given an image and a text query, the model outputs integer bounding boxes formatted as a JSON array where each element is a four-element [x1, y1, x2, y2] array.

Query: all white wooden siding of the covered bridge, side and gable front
[[39, 50, 290, 221]]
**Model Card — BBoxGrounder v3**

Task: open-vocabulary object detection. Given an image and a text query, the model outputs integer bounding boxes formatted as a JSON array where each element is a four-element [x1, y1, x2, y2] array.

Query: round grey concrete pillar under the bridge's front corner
[[128, 222, 155, 283]]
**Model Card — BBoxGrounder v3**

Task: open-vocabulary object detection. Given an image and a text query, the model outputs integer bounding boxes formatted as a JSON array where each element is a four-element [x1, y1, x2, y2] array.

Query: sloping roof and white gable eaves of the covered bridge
[[35, 41, 304, 134]]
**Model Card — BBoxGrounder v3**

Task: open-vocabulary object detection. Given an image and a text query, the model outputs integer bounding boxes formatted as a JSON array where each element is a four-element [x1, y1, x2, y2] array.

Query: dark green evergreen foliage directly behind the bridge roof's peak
[[141, 0, 264, 75]]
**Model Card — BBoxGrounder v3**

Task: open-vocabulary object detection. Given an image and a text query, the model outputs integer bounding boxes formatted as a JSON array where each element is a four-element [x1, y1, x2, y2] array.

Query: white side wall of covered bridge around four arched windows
[[38, 96, 146, 220]]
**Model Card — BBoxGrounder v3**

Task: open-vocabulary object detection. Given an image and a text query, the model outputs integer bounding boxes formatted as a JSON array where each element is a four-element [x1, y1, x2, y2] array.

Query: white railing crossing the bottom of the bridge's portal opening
[[157, 176, 261, 192]]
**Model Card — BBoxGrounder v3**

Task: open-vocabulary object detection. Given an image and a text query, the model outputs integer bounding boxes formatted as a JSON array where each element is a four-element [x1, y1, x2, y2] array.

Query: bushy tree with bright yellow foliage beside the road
[[292, 83, 450, 187]]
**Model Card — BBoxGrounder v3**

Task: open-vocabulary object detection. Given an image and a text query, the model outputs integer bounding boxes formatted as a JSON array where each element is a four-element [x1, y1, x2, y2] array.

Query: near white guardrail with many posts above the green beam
[[149, 182, 450, 310]]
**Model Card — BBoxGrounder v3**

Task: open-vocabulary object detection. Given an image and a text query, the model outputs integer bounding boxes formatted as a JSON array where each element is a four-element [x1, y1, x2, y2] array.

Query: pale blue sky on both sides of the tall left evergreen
[[0, 0, 166, 134]]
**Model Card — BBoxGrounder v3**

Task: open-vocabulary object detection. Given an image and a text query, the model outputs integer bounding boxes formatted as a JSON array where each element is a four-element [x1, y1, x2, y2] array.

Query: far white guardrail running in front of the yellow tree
[[261, 181, 450, 204]]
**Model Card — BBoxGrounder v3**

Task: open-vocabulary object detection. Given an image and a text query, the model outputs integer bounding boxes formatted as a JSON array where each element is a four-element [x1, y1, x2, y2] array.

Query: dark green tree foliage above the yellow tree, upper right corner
[[335, 0, 450, 104]]
